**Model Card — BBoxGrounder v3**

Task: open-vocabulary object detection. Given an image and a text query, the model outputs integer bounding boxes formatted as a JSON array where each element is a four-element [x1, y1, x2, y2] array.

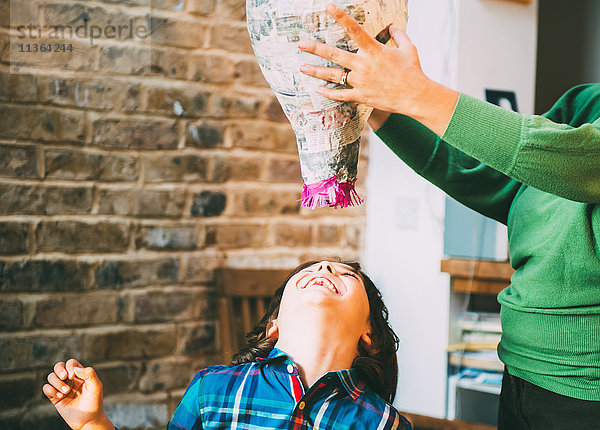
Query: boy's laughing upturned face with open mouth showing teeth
[[277, 261, 370, 345]]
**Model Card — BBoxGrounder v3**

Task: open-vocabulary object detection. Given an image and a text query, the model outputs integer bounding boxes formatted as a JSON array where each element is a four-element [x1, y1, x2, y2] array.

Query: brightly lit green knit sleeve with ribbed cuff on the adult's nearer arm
[[443, 91, 600, 203]]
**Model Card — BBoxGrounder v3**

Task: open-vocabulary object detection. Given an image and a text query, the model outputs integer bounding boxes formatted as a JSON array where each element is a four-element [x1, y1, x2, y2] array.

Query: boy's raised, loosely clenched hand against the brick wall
[[42, 359, 114, 430]]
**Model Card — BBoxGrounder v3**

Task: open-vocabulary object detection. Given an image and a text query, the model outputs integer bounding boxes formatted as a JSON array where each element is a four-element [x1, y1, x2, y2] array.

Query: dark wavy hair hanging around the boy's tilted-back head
[[230, 261, 399, 403]]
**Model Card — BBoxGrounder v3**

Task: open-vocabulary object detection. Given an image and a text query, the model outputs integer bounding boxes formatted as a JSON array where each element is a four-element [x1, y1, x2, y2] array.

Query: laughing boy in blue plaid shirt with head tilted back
[[43, 261, 411, 430]]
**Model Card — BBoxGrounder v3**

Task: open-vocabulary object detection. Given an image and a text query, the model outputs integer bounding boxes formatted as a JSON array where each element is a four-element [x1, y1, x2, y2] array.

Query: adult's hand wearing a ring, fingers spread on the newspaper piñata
[[298, 4, 459, 136]]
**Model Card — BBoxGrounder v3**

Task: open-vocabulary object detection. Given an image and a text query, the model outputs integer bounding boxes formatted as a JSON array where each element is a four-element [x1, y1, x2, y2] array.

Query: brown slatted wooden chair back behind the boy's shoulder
[[215, 268, 289, 364]]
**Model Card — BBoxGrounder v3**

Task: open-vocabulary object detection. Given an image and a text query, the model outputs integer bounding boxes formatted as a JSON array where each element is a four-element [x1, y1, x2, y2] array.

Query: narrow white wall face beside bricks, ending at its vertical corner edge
[[363, 0, 457, 417]]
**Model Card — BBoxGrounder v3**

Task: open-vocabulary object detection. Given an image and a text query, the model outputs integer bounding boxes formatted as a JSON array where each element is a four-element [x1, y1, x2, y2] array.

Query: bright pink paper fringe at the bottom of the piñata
[[300, 176, 363, 209]]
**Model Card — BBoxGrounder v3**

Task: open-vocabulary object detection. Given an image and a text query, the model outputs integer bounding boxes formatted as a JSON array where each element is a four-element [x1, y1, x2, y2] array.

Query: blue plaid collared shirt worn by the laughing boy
[[167, 348, 411, 430]]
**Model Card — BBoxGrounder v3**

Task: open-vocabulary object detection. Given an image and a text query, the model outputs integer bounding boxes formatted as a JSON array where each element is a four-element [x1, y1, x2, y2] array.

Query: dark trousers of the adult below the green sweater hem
[[498, 369, 600, 430]]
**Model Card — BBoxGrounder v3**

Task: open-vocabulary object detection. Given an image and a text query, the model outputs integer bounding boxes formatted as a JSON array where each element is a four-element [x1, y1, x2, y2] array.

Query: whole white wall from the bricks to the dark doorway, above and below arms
[[363, 0, 537, 417]]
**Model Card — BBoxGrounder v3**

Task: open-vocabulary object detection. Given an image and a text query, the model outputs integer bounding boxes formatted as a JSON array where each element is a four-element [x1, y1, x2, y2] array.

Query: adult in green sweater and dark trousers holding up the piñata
[[299, 5, 600, 430]]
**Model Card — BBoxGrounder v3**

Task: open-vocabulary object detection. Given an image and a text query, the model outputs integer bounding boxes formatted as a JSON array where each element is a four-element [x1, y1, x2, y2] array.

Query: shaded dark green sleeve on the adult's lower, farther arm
[[375, 114, 521, 224]]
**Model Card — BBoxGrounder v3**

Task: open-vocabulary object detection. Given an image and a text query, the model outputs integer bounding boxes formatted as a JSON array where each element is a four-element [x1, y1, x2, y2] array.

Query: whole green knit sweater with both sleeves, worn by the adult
[[376, 84, 600, 401]]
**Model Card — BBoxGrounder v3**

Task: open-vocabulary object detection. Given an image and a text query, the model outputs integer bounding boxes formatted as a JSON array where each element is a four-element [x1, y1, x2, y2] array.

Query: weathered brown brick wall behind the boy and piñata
[[0, 0, 367, 429]]
